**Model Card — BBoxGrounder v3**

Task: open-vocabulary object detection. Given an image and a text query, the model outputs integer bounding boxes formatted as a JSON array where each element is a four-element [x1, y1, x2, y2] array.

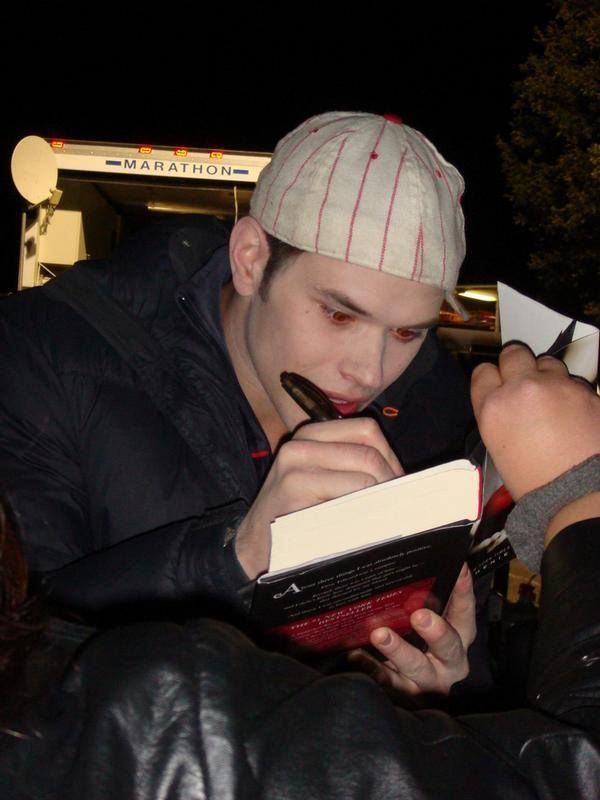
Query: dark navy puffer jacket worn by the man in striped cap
[[0, 220, 472, 614]]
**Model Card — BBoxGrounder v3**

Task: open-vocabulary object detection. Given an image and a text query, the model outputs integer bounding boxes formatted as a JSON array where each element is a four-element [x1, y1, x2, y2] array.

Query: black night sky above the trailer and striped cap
[[0, 0, 550, 291]]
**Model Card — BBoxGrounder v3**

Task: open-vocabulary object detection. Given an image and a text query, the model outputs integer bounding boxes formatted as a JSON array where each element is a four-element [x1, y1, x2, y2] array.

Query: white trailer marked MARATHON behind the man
[[11, 136, 270, 289]]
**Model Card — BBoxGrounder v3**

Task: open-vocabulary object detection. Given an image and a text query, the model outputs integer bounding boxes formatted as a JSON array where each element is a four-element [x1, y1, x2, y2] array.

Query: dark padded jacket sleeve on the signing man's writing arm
[[0, 298, 247, 617]]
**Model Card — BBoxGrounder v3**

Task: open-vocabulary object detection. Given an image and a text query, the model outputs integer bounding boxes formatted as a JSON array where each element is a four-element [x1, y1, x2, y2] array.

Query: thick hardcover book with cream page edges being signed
[[252, 459, 481, 652]]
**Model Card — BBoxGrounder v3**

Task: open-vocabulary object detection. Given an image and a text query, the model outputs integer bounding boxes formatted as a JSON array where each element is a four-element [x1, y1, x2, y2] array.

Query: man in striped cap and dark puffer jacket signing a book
[[0, 113, 474, 689]]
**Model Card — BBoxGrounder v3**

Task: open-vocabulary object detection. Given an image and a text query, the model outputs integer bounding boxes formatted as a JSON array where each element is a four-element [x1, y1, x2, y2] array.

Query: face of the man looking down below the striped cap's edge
[[238, 253, 442, 438]]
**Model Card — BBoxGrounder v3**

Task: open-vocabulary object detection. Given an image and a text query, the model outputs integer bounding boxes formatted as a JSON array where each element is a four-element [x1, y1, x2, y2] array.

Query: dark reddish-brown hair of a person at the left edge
[[0, 493, 46, 698]]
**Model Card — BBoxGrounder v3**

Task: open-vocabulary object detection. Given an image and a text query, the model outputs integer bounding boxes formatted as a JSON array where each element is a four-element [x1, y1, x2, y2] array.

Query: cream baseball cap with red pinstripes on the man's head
[[250, 111, 465, 291]]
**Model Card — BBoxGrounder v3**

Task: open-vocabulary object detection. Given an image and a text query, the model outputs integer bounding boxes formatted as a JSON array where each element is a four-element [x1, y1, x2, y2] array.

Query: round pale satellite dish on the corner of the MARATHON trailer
[[10, 136, 58, 206]]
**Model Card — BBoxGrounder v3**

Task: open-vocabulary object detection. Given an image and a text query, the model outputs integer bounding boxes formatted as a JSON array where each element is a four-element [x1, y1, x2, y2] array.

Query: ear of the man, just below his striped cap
[[229, 217, 270, 296]]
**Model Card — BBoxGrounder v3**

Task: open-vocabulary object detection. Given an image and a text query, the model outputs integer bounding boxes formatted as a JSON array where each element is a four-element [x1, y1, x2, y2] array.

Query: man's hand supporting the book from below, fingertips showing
[[350, 565, 476, 695]]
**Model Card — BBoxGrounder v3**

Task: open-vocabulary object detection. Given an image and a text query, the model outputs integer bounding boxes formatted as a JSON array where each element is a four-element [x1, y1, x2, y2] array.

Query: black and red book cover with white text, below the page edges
[[252, 522, 472, 653]]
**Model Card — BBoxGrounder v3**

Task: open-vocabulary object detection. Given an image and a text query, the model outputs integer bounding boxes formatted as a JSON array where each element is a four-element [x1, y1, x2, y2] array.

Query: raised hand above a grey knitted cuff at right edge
[[471, 345, 600, 500]]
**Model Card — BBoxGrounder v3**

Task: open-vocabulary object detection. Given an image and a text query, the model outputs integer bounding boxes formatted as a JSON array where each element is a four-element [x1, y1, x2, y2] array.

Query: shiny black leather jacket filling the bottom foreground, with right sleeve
[[0, 518, 600, 800]]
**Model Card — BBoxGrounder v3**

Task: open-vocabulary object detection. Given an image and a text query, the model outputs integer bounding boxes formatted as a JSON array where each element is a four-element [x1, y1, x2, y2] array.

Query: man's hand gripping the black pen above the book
[[235, 417, 403, 579]]
